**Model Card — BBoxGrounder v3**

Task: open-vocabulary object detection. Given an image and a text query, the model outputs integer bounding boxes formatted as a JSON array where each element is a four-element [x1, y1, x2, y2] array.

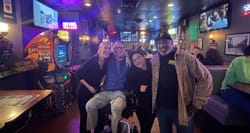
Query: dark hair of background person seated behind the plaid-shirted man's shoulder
[[206, 48, 224, 64]]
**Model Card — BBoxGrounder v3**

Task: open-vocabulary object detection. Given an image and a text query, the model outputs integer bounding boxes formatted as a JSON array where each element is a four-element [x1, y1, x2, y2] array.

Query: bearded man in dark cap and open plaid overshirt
[[151, 33, 213, 133]]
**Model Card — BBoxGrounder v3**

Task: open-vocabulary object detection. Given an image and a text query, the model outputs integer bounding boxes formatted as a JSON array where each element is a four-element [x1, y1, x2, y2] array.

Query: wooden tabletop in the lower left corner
[[0, 90, 52, 129]]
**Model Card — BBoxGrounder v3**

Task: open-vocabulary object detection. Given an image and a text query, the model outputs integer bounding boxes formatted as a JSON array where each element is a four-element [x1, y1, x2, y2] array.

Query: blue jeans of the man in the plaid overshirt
[[156, 107, 193, 133]]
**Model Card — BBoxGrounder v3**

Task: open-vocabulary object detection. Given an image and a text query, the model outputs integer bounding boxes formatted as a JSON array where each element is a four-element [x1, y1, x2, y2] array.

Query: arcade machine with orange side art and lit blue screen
[[24, 30, 72, 114]]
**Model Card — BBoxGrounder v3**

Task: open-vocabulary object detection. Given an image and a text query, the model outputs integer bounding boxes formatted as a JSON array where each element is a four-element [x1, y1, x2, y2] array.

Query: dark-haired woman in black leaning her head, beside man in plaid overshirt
[[126, 51, 154, 133]]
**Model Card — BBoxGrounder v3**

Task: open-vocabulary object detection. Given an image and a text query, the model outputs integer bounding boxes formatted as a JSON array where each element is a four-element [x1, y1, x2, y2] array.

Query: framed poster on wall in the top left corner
[[0, 0, 16, 23]]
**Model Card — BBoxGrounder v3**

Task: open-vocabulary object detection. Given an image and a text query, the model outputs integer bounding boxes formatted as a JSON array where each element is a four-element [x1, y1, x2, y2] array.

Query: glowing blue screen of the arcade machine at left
[[56, 45, 68, 63]]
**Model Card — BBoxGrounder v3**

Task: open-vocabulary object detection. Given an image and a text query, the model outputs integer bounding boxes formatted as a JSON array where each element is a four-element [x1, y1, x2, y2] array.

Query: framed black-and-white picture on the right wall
[[225, 33, 250, 55]]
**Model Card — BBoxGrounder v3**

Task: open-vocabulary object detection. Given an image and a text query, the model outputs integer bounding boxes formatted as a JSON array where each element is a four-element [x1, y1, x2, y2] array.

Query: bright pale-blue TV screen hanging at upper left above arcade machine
[[33, 0, 58, 29]]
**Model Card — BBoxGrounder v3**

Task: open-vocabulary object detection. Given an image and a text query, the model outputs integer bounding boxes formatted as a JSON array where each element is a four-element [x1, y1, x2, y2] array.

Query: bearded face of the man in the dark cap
[[156, 39, 173, 55]]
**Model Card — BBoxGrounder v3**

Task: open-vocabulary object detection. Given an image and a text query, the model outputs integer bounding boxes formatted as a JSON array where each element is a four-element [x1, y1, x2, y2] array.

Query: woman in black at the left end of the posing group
[[77, 42, 111, 133]]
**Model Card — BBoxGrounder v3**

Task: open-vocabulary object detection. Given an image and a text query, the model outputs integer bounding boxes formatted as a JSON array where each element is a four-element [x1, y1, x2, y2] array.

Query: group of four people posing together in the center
[[78, 33, 213, 133]]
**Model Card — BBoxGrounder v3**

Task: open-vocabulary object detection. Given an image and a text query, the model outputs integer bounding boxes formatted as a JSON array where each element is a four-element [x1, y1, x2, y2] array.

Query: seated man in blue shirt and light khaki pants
[[86, 42, 128, 133]]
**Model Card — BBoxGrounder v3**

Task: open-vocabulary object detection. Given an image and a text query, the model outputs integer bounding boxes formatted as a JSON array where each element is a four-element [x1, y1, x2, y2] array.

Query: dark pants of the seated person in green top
[[220, 88, 250, 119]]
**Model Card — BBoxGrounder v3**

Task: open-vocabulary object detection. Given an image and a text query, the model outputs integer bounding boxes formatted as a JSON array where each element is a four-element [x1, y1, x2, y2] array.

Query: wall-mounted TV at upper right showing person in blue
[[199, 3, 230, 32]]
